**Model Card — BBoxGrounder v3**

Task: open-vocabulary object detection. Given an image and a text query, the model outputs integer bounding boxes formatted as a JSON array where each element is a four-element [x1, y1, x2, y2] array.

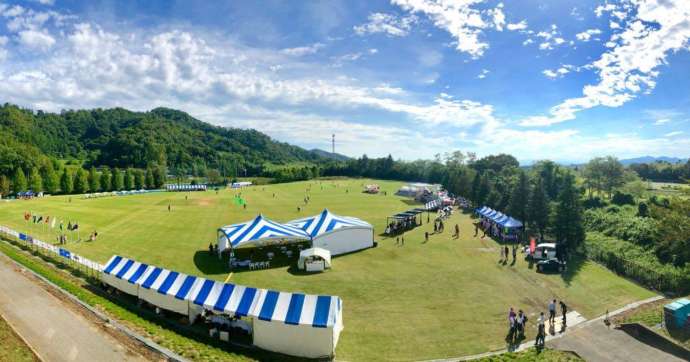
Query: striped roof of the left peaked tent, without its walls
[[219, 215, 309, 248]]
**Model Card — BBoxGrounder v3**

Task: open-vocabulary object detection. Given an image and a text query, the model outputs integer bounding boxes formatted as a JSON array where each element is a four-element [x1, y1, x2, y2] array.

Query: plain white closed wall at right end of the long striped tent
[[254, 318, 339, 358]]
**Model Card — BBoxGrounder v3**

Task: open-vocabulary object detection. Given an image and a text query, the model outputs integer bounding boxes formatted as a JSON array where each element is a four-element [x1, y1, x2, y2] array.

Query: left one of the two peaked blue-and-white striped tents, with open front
[[218, 215, 310, 252]]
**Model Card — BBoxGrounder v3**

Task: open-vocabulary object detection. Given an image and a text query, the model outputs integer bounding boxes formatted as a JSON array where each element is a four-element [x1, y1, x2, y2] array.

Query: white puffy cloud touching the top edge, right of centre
[[391, 0, 498, 58]]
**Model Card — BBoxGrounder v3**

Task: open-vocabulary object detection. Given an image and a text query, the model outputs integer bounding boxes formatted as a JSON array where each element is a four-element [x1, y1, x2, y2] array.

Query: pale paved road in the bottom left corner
[[0, 253, 145, 362]]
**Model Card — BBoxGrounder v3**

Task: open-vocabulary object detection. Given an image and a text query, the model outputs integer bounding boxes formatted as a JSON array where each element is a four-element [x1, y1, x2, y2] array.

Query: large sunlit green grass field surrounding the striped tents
[[0, 179, 653, 361]]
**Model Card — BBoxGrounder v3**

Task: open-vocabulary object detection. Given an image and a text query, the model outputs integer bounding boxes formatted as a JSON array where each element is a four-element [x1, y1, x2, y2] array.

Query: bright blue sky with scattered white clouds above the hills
[[0, 0, 690, 162]]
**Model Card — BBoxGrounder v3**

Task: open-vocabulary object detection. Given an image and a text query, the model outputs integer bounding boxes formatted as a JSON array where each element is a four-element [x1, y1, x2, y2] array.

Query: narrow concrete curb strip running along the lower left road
[[0, 239, 188, 362]]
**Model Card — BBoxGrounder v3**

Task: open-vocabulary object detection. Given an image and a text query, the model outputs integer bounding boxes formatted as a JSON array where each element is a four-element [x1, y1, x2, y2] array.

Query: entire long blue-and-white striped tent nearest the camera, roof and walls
[[101, 255, 343, 358]]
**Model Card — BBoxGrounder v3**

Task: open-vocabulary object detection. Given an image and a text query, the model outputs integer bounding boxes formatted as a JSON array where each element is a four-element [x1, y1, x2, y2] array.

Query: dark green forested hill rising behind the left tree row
[[0, 104, 326, 174]]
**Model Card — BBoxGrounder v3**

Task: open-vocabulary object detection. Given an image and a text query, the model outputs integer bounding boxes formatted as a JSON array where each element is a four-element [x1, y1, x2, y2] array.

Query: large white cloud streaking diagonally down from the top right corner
[[521, 0, 690, 126]]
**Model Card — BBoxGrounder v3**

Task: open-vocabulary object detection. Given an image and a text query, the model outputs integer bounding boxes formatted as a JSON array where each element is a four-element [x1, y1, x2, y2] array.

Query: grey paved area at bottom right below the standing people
[[546, 321, 683, 362]]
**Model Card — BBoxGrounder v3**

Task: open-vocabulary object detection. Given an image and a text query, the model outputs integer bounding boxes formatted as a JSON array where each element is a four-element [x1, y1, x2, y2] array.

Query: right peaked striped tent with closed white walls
[[287, 209, 374, 255]]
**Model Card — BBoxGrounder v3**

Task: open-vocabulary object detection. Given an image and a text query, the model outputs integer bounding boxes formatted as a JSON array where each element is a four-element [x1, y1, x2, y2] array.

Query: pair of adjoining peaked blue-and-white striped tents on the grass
[[218, 209, 374, 255]]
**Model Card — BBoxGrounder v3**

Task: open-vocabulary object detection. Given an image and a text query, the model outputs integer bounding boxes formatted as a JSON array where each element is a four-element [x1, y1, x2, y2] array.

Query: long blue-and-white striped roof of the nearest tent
[[103, 255, 342, 328]]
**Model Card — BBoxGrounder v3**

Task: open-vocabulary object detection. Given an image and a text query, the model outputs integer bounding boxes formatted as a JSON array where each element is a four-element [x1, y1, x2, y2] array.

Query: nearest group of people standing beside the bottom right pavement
[[506, 299, 568, 348]]
